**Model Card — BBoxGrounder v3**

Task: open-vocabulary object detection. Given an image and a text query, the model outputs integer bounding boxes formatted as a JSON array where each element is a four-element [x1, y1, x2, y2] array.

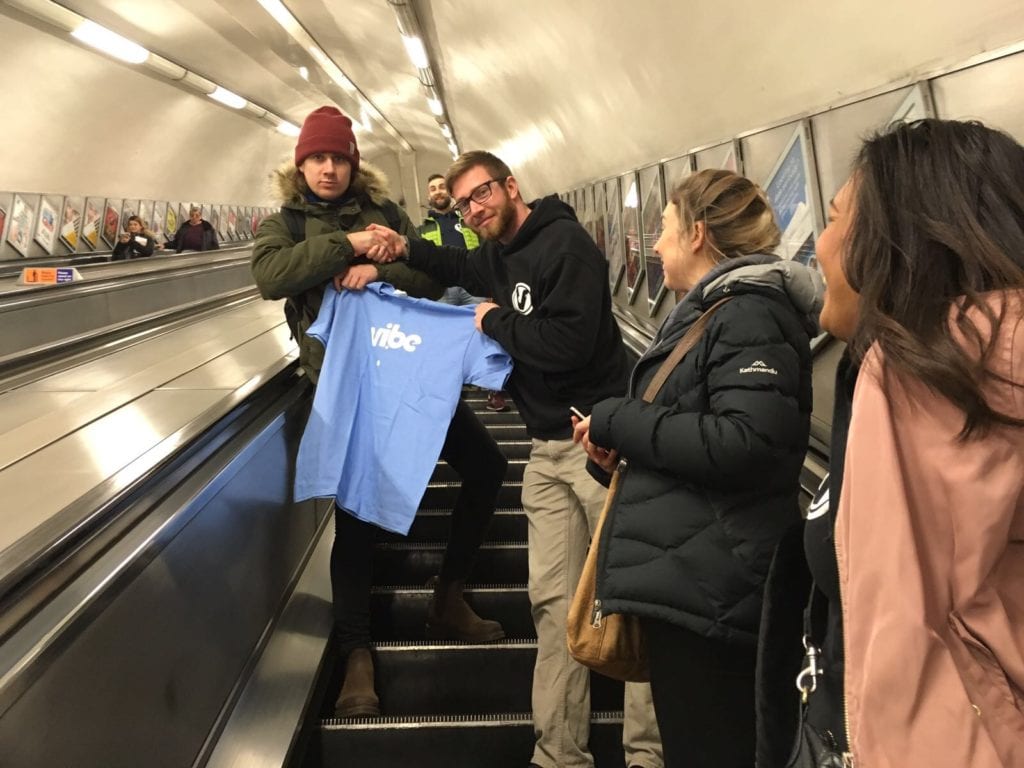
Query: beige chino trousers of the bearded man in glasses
[[522, 439, 664, 768]]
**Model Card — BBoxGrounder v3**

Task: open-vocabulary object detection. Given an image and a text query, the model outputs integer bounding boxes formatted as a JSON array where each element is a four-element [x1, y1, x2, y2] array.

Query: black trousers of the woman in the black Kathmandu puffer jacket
[[641, 618, 757, 768]]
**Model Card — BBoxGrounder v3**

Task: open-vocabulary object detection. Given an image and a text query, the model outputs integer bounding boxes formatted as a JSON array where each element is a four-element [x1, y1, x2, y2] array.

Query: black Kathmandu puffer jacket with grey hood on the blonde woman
[[590, 256, 822, 644]]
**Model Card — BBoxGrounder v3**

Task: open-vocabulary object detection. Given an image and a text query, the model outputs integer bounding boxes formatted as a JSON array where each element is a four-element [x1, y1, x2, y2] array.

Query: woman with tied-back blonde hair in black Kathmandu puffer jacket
[[575, 170, 823, 768]]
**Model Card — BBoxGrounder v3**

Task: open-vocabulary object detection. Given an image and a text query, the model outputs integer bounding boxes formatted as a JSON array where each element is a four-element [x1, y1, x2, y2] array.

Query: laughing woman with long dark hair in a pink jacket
[[805, 120, 1024, 768]]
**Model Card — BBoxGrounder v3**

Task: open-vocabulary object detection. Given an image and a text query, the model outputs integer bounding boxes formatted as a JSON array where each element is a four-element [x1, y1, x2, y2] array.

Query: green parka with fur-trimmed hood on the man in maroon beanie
[[252, 162, 444, 383]]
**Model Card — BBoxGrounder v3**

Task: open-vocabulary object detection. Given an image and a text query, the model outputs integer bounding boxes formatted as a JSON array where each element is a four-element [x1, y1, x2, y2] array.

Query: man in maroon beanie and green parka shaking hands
[[252, 106, 508, 717]]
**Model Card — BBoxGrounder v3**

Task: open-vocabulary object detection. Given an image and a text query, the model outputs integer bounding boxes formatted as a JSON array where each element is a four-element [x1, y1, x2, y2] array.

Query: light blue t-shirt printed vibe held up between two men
[[295, 283, 512, 535]]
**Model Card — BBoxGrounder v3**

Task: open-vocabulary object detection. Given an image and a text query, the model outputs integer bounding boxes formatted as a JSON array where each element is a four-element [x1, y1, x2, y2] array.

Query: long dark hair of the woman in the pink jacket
[[845, 120, 1024, 439]]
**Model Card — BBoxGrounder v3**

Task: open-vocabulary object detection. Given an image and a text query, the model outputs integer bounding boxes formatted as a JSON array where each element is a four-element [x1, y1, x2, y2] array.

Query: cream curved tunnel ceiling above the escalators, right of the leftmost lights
[[39, 0, 1024, 193]]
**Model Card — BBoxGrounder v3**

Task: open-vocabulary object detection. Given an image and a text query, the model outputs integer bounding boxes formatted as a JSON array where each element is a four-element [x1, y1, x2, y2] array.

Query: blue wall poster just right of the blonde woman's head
[[764, 121, 822, 268]]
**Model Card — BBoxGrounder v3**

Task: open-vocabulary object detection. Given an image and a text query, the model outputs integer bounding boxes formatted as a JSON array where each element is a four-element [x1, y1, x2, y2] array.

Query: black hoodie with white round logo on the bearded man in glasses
[[409, 195, 630, 440]]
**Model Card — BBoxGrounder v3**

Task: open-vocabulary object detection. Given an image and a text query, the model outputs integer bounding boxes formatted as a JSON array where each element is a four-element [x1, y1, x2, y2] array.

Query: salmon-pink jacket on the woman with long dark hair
[[836, 292, 1024, 768]]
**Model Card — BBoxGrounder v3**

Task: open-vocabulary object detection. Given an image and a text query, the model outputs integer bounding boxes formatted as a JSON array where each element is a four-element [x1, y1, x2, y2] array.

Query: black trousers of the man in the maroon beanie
[[331, 400, 508, 653]]
